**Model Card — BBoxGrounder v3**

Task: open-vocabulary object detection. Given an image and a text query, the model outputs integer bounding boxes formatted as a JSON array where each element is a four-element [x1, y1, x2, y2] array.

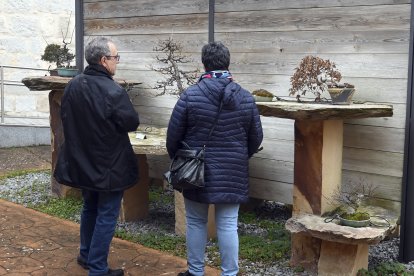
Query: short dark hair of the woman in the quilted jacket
[[201, 42, 230, 71]]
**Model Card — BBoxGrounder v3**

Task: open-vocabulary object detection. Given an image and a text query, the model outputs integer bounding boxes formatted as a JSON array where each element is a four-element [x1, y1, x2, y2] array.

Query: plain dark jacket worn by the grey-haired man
[[54, 65, 139, 191]]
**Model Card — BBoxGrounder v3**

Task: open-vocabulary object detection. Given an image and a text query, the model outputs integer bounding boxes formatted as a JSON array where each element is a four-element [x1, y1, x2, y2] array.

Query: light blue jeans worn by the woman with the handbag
[[184, 198, 240, 276]]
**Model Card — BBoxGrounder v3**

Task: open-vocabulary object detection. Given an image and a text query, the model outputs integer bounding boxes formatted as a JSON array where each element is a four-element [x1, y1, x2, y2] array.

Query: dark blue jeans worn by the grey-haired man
[[80, 190, 124, 276]]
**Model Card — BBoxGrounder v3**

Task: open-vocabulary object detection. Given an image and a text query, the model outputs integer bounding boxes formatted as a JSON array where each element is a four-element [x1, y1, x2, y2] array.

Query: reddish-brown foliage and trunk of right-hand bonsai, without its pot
[[289, 56, 342, 101]]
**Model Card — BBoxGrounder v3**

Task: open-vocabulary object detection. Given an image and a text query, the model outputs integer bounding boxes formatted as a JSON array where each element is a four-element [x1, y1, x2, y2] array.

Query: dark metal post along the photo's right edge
[[399, 0, 414, 263]]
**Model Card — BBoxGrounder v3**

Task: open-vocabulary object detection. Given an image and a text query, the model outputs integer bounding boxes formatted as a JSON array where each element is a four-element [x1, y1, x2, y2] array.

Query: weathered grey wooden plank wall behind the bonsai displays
[[84, 0, 411, 207]]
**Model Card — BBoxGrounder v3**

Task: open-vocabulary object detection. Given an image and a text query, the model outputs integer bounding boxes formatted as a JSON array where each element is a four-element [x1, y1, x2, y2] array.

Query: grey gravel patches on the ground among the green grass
[[0, 173, 414, 276]]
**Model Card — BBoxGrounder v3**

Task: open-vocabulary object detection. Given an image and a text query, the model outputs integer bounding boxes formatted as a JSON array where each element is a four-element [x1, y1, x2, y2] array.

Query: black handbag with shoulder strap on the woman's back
[[164, 99, 223, 192]]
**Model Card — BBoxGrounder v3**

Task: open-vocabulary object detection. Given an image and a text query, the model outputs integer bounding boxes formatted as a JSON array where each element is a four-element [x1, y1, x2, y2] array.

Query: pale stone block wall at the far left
[[0, 0, 75, 127]]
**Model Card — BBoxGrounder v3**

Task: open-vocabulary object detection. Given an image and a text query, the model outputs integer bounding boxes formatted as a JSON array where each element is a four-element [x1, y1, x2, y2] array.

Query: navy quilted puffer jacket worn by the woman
[[167, 78, 263, 203]]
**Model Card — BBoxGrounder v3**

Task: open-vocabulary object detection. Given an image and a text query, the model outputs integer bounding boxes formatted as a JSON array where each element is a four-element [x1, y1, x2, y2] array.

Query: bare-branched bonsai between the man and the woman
[[151, 38, 199, 95]]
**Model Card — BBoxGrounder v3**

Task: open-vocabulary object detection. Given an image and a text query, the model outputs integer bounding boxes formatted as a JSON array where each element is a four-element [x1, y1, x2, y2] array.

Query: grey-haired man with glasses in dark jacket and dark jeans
[[54, 37, 139, 276]]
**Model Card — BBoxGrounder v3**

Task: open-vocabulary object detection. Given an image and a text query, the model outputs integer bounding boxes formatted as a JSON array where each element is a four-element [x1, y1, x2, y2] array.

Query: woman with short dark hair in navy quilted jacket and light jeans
[[167, 42, 263, 276]]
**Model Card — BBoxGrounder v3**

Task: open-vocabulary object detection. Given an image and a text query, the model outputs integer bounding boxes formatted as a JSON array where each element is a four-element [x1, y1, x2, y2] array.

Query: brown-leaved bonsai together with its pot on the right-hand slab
[[289, 55, 355, 103]]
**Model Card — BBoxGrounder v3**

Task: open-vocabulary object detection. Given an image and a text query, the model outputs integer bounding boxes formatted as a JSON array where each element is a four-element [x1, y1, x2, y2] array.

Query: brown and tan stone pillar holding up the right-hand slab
[[290, 120, 343, 272]]
